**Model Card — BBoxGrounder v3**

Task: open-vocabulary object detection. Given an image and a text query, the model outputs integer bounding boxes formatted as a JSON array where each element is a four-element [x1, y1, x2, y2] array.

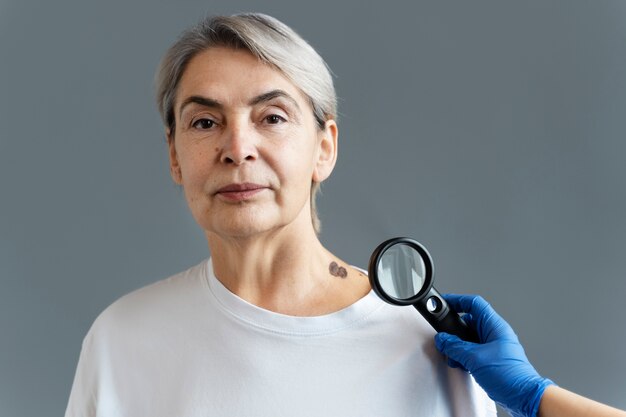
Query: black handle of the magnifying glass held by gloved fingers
[[413, 287, 480, 343]]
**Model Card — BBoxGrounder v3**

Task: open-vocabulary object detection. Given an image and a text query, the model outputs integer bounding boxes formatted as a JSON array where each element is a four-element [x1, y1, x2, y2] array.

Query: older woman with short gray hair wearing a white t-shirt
[[66, 14, 496, 417]]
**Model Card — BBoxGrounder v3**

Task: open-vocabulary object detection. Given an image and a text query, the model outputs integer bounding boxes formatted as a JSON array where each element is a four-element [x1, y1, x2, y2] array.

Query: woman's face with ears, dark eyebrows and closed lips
[[167, 48, 337, 237]]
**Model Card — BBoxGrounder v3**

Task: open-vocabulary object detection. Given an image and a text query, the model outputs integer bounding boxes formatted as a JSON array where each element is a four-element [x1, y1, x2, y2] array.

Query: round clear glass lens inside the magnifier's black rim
[[377, 243, 426, 300]]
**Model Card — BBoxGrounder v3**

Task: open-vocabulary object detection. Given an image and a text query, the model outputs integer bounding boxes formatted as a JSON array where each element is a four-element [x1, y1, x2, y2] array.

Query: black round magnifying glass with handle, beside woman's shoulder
[[369, 237, 478, 343]]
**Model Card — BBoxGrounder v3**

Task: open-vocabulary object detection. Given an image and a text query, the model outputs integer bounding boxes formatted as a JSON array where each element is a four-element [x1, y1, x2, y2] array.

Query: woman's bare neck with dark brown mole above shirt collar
[[207, 219, 370, 316]]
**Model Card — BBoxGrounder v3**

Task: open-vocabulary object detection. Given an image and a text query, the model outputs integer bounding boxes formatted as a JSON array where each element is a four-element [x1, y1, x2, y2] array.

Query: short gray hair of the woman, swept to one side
[[156, 13, 337, 233]]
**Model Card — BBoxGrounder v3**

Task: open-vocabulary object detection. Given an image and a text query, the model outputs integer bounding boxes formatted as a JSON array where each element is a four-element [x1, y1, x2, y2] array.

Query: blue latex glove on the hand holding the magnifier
[[435, 294, 554, 417]]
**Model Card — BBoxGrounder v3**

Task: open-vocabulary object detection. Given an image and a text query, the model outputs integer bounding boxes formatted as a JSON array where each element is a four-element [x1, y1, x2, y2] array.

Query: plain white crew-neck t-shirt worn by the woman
[[65, 260, 496, 417]]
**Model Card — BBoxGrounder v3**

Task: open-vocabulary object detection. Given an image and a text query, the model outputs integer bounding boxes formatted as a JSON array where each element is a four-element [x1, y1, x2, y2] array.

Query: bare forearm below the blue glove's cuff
[[538, 385, 626, 417]]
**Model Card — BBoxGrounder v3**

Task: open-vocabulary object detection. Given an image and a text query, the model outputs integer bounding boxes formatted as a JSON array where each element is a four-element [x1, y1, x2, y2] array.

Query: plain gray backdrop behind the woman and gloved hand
[[0, 0, 626, 416]]
